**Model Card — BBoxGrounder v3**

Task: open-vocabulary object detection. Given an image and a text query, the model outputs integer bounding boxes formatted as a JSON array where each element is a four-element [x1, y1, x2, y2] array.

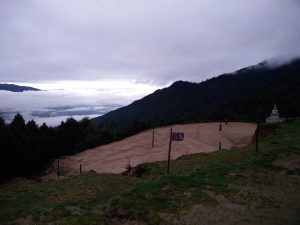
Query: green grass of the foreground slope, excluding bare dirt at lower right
[[0, 121, 300, 224]]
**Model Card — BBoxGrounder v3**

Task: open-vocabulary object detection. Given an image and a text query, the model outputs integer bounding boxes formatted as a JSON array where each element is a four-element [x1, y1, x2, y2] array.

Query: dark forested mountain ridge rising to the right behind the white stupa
[[92, 59, 300, 126]]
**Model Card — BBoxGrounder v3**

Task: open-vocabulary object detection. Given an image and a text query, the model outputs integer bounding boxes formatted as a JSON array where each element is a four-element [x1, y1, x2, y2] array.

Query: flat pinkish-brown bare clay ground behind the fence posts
[[44, 122, 256, 179]]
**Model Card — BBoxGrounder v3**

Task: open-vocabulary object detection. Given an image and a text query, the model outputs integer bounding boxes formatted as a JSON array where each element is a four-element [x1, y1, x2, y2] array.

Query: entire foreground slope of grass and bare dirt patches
[[0, 121, 300, 225]]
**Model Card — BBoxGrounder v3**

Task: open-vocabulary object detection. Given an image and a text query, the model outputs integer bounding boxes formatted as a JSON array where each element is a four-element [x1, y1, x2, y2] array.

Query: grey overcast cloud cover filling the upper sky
[[0, 0, 300, 84]]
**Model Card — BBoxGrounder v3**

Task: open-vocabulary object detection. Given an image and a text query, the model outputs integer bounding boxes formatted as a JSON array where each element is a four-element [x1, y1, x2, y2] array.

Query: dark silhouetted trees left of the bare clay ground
[[0, 114, 149, 182]]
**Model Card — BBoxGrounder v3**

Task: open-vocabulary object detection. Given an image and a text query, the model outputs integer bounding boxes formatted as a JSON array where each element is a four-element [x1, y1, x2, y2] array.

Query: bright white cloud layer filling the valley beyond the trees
[[0, 80, 160, 126]]
